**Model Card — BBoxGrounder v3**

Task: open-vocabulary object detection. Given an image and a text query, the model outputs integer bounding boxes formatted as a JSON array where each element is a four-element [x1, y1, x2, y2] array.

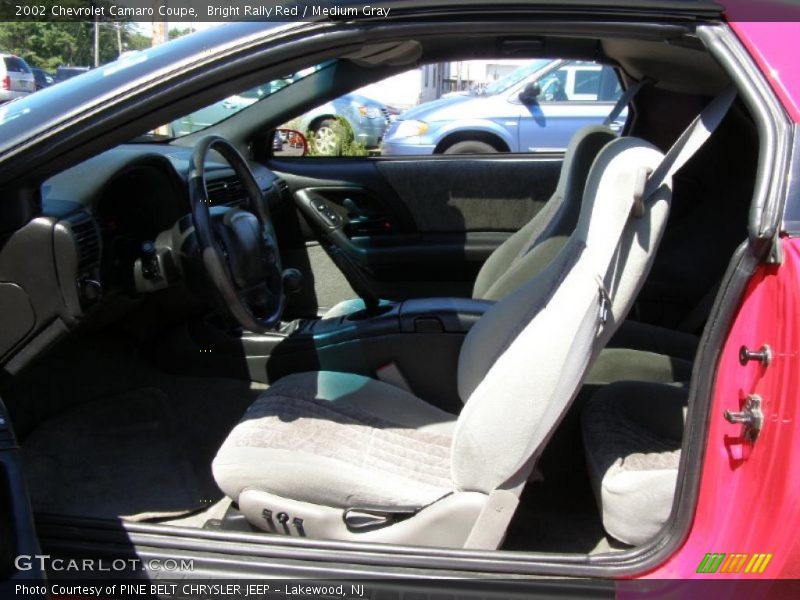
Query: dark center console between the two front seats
[[158, 298, 493, 410]]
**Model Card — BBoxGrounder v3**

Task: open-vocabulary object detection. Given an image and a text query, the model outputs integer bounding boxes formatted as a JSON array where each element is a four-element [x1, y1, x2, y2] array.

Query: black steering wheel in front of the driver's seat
[[188, 135, 286, 333]]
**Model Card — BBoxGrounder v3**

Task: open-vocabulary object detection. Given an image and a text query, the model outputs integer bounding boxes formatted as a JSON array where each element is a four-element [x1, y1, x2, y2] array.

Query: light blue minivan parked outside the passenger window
[[381, 59, 627, 155]]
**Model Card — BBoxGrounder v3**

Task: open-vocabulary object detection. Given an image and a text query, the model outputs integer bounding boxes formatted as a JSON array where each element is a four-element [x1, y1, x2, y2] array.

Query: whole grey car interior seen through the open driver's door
[[0, 21, 762, 555]]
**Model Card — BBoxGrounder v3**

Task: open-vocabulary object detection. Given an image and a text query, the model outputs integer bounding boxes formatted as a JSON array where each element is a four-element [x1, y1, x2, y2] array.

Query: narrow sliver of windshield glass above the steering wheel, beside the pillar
[[166, 61, 335, 138]]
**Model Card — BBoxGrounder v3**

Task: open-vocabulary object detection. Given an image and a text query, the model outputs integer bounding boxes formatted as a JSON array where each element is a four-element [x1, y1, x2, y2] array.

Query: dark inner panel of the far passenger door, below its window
[[268, 154, 563, 316]]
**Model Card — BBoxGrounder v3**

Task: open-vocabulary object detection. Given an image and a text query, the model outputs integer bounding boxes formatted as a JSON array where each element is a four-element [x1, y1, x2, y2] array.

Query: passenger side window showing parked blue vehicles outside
[[273, 58, 624, 160]]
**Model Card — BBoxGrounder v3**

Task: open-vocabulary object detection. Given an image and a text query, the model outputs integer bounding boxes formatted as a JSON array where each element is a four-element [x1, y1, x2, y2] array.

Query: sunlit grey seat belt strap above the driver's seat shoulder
[[642, 87, 736, 202]]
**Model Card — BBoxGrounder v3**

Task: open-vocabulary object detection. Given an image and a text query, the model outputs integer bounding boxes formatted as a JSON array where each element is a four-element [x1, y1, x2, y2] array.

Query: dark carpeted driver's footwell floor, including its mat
[[4, 330, 264, 521]]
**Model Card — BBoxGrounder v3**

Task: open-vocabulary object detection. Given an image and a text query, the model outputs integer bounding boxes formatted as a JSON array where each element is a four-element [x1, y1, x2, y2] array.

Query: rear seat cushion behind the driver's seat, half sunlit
[[582, 381, 688, 545]]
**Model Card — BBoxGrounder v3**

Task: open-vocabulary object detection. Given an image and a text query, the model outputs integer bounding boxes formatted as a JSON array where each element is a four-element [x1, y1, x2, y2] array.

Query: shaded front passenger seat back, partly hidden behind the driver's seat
[[472, 125, 617, 300]]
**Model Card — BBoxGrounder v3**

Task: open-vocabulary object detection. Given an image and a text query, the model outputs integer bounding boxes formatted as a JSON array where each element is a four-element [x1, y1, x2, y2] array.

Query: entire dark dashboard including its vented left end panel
[[0, 144, 286, 370]]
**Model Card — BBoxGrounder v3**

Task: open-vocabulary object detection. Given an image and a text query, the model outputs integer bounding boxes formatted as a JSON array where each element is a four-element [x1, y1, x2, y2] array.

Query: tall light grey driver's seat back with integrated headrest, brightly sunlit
[[452, 138, 672, 494]]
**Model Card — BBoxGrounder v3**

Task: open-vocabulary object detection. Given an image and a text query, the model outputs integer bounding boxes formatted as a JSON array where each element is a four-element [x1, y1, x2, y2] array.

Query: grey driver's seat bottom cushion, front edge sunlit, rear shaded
[[213, 371, 456, 508]]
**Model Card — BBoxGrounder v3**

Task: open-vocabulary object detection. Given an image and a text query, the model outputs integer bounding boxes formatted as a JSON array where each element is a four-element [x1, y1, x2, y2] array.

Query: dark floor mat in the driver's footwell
[[22, 388, 220, 520]]
